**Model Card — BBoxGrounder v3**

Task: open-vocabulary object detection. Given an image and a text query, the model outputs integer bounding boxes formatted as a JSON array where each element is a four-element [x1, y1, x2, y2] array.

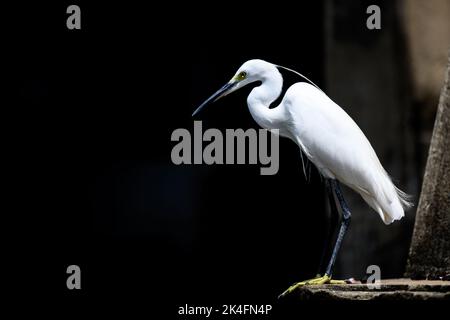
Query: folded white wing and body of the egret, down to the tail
[[282, 83, 408, 223]]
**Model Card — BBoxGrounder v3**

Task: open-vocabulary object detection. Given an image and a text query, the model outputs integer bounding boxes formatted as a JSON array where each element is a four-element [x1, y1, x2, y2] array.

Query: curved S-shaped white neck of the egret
[[247, 70, 285, 129]]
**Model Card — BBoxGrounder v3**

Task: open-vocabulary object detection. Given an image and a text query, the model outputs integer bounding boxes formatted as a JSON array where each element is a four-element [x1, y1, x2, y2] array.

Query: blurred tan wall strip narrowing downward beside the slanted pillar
[[398, 0, 450, 164]]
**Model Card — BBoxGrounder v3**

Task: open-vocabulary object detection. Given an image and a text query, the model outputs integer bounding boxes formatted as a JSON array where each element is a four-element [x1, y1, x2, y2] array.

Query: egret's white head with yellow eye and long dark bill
[[192, 59, 278, 116]]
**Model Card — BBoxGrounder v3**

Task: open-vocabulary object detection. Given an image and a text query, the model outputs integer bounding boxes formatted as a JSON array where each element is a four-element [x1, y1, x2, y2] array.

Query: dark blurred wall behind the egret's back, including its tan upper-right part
[[324, 0, 450, 277]]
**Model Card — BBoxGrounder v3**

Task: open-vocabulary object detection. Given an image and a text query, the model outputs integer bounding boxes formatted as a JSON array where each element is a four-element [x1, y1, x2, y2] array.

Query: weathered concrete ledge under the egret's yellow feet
[[292, 279, 450, 301]]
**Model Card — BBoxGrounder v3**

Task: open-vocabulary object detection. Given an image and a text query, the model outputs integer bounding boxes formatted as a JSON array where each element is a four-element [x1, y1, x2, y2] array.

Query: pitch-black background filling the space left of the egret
[[13, 1, 442, 318]]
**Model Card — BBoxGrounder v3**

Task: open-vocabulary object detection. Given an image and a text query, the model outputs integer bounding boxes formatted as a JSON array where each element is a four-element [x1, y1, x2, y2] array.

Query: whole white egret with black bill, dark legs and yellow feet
[[193, 59, 412, 295]]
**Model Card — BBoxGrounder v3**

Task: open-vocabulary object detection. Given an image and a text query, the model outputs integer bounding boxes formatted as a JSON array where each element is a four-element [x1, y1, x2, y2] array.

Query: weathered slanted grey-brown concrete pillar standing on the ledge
[[406, 53, 450, 279]]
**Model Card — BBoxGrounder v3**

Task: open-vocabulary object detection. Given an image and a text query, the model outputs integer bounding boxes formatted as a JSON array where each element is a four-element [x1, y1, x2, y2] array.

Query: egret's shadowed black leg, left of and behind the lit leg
[[317, 179, 339, 275]]
